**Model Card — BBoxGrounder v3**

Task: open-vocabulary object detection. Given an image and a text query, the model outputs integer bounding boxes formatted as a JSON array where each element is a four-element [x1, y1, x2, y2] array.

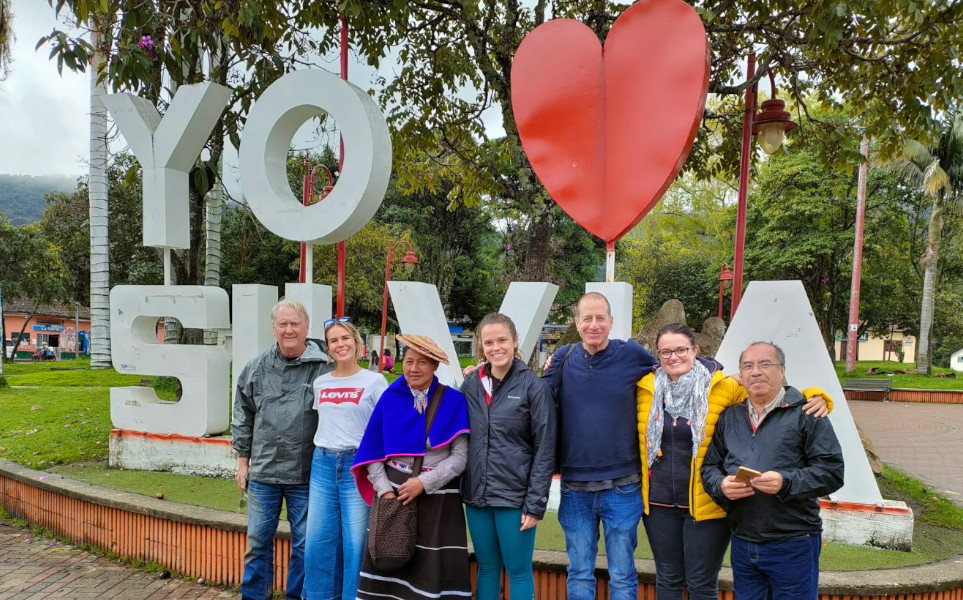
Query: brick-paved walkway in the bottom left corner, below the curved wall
[[0, 520, 239, 600]]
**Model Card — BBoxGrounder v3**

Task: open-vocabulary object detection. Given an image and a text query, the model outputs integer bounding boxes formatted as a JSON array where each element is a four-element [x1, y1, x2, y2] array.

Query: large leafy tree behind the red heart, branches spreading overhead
[[235, 0, 963, 280]]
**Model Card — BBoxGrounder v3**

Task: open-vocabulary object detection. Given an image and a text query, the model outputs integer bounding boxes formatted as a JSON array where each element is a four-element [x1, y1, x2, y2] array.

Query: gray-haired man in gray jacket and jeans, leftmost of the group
[[231, 300, 332, 600]]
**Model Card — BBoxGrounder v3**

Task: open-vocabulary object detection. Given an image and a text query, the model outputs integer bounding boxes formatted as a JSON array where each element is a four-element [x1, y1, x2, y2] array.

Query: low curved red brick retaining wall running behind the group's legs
[[0, 460, 963, 600]]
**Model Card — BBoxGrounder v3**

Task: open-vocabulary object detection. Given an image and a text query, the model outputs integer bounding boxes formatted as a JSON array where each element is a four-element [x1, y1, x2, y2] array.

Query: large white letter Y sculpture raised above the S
[[104, 82, 231, 250]]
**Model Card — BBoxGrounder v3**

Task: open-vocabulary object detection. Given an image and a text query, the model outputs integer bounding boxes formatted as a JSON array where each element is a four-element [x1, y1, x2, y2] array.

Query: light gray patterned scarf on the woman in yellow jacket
[[645, 360, 712, 468]]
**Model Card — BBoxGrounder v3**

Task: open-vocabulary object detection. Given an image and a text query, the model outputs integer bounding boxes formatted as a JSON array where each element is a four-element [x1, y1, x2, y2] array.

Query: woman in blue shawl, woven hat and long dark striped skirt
[[351, 334, 471, 600]]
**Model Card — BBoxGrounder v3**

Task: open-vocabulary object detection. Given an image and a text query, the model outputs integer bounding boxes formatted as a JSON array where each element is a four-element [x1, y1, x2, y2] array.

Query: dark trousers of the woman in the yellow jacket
[[642, 504, 729, 600]]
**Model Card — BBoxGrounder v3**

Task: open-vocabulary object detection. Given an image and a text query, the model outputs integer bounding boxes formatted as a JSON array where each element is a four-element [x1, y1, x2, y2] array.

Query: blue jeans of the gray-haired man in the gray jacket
[[241, 481, 308, 600]]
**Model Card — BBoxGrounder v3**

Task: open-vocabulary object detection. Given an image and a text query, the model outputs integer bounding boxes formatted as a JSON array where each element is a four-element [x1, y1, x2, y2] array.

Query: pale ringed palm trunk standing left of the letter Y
[[88, 30, 111, 369]]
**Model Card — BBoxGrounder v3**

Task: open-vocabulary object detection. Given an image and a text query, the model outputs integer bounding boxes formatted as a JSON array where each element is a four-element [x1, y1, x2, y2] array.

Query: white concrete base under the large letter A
[[819, 500, 913, 552]]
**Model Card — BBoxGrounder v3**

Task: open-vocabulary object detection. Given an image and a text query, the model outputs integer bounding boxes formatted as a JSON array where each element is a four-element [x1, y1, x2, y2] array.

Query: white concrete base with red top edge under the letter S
[[110, 429, 237, 478]]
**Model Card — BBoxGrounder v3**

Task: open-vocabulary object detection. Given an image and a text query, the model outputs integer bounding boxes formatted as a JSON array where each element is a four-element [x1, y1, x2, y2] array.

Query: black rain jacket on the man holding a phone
[[702, 387, 843, 542]]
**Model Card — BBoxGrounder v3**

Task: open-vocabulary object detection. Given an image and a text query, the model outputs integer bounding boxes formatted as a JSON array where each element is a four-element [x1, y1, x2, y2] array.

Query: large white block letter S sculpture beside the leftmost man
[[110, 285, 231, 437]]
